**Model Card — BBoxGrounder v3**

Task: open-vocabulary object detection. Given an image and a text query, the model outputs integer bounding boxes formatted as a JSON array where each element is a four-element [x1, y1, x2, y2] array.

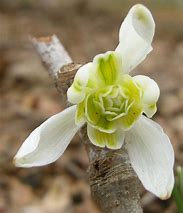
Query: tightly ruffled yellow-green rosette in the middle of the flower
[[85, 76, 142, 132]]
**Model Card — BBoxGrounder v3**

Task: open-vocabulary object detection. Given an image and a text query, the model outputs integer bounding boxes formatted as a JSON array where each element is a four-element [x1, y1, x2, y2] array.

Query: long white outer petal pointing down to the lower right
[[126, 116, 174, 199]]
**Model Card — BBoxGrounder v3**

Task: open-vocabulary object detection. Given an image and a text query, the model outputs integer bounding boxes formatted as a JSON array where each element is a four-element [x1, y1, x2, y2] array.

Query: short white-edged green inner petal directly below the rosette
[[87, 124, 125, 149]]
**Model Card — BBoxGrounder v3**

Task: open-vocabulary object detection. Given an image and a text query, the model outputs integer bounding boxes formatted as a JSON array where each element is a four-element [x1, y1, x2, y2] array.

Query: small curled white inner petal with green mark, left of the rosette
[[67, 62, 92, 104]]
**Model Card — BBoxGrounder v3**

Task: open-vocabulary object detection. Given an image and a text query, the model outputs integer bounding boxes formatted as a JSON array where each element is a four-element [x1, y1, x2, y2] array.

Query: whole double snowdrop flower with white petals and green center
[[15, 4, 174, 199]]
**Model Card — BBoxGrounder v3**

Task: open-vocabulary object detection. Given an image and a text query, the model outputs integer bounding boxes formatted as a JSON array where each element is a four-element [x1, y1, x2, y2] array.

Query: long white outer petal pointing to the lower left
[[14, 106, 80, 167]]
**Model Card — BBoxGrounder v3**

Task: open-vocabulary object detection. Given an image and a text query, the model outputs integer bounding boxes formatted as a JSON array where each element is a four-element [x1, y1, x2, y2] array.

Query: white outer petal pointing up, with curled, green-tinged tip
[[116, 4, 155, 73]]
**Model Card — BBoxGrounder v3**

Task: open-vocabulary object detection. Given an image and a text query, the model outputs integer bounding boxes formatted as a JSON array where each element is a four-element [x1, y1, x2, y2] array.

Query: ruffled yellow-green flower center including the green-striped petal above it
[[76, 53, 142, 133]]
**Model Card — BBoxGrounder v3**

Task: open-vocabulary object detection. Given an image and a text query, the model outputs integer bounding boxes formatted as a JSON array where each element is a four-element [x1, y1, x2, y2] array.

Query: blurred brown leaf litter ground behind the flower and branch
[[0, 0, 183, 213]]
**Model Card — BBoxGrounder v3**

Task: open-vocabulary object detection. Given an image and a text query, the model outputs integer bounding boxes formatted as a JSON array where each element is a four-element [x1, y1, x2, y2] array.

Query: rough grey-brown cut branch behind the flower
[[32, 35, 142, 213]]
